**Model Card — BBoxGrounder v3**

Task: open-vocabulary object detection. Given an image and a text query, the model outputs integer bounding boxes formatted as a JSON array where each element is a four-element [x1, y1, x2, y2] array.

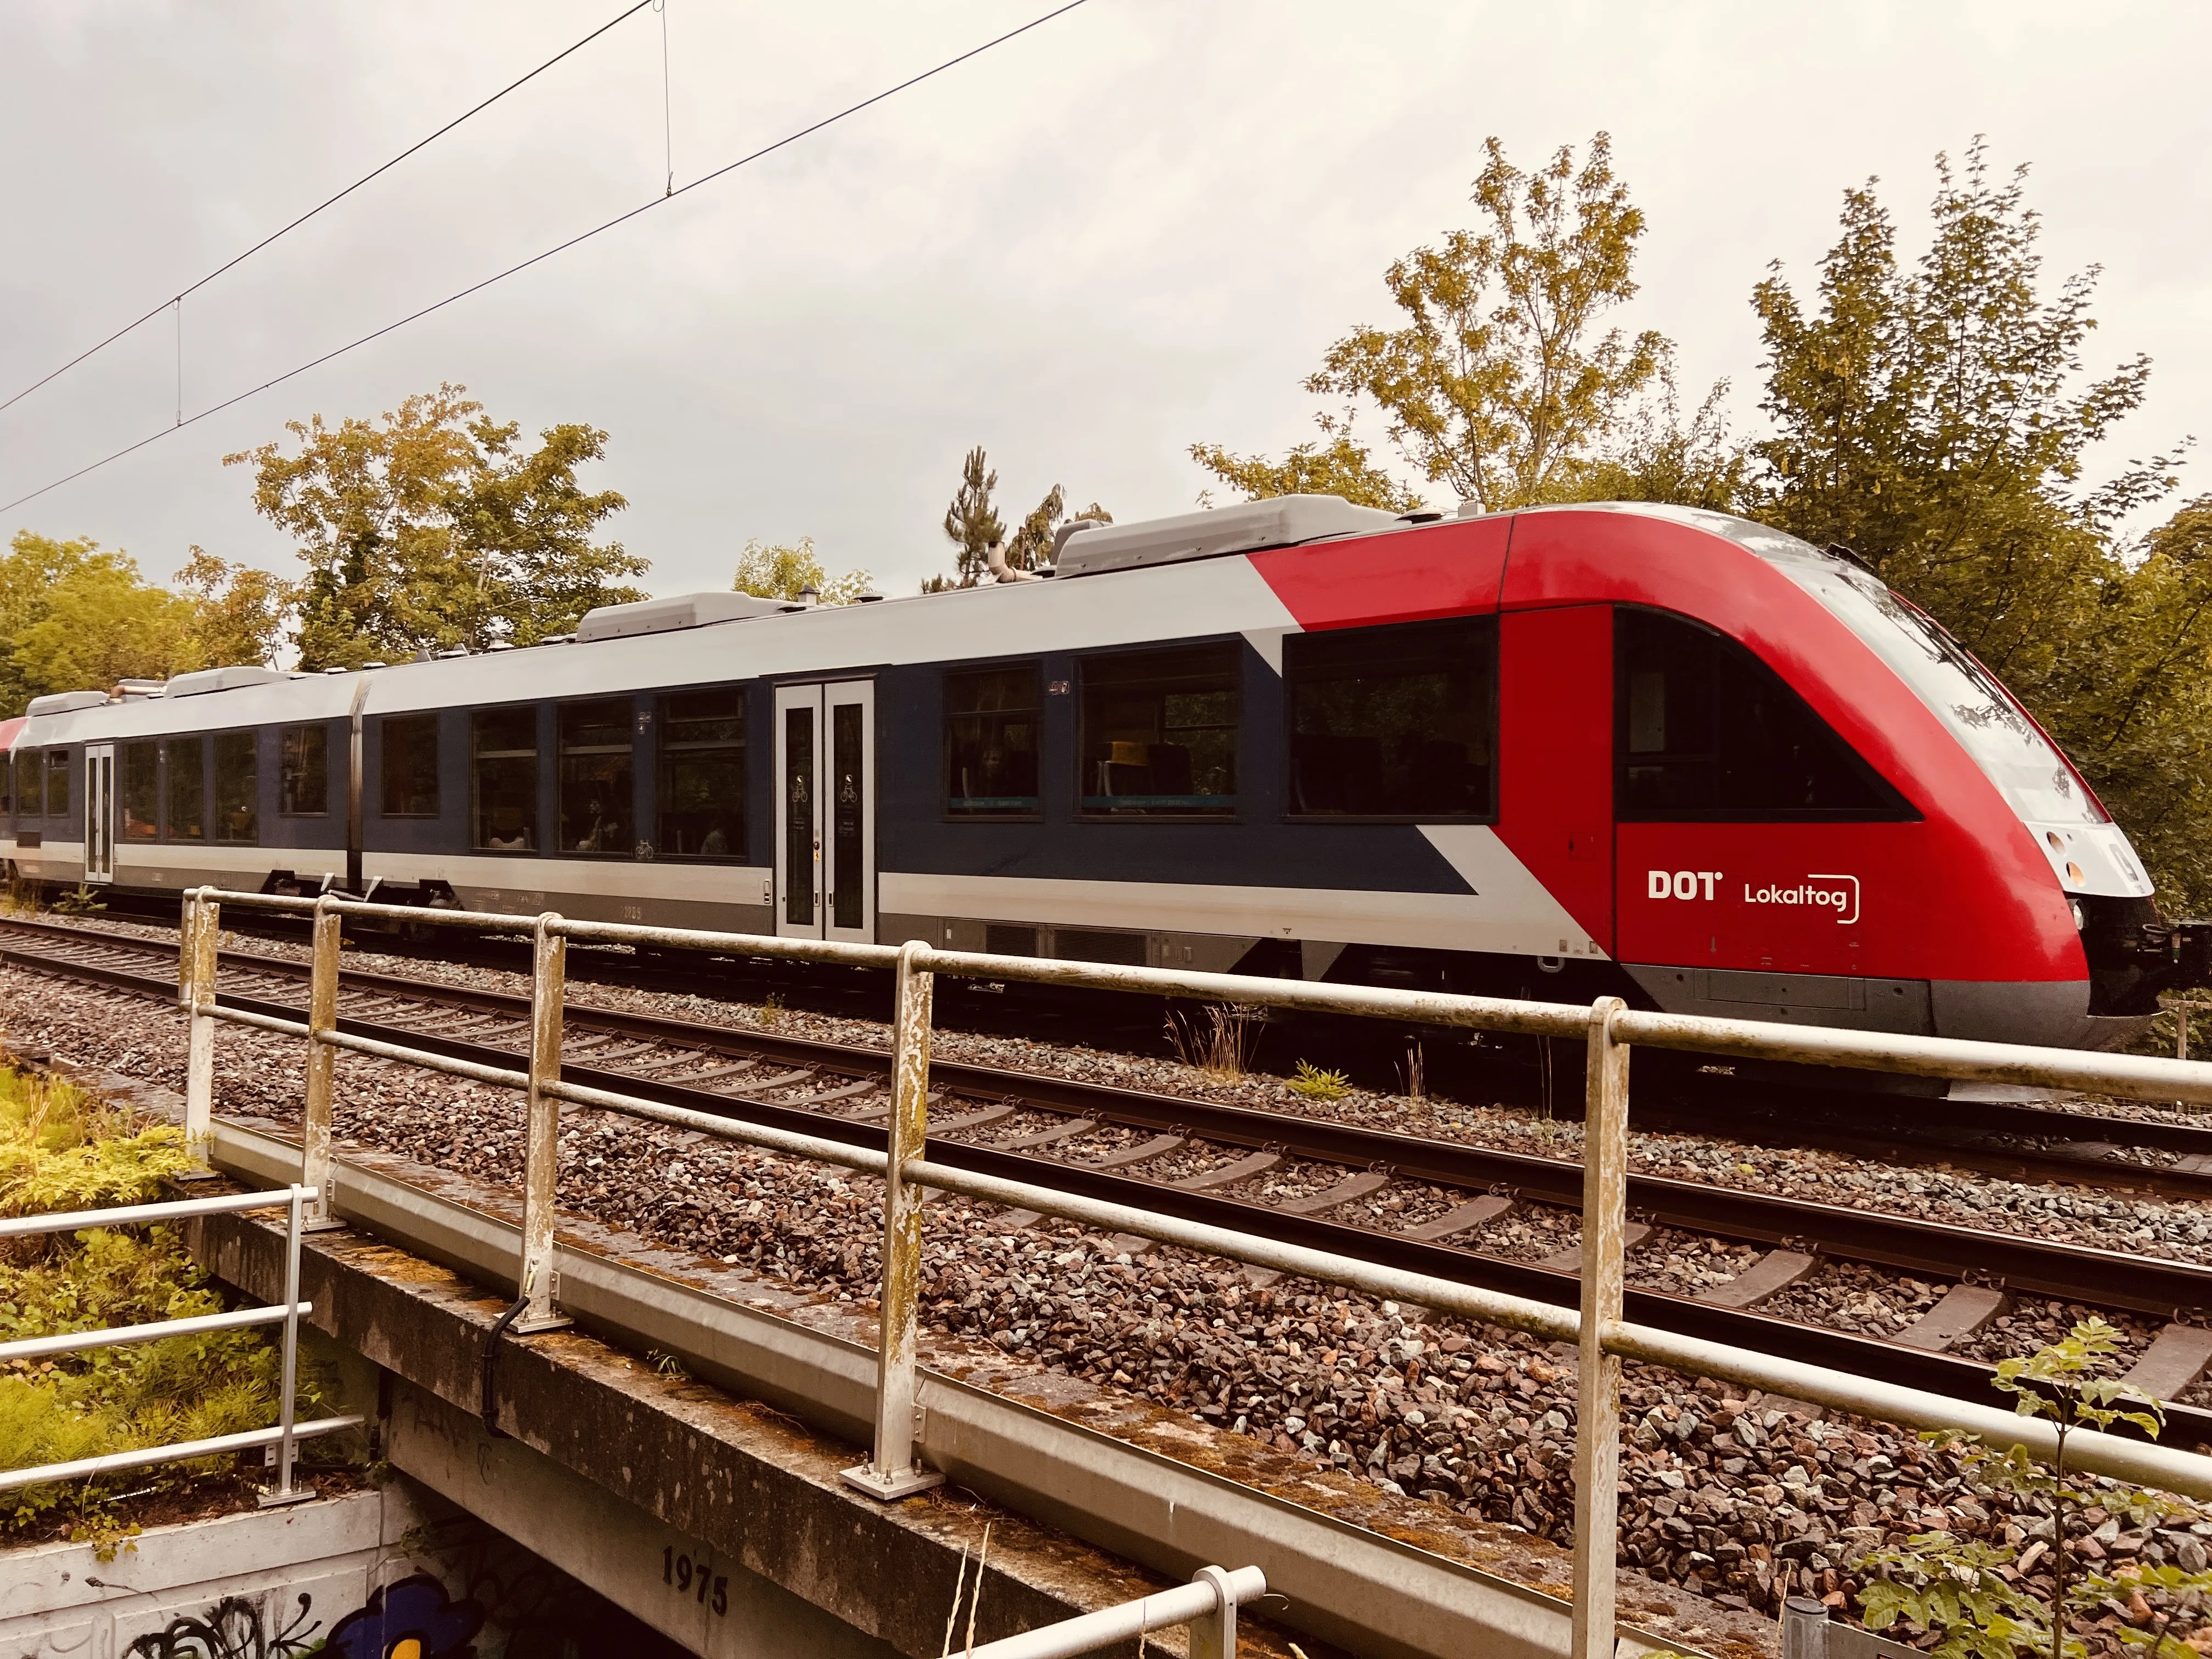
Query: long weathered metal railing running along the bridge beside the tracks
[[179, 887, 2212, 1659]]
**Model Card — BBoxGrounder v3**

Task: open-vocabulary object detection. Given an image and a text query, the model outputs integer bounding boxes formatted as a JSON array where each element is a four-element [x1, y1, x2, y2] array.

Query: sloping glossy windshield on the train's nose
[[1723, 520, 2108, 823]]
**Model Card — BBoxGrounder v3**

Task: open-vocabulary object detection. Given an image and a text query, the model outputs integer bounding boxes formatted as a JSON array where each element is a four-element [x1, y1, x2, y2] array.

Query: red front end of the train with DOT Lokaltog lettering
[[1586, 509, 2212, 1048]]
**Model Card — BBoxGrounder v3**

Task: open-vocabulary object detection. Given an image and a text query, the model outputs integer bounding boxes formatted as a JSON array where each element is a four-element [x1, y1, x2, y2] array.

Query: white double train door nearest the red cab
[[776, 679, 876, 945]]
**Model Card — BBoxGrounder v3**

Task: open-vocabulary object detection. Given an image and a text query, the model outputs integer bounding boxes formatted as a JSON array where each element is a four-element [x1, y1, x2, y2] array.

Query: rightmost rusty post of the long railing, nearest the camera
[[1571, 997, 1628, 1659]]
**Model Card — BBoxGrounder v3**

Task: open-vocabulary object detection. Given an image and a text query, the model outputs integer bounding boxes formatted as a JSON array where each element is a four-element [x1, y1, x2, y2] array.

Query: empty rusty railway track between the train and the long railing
[[0, 918, 2212, 1444]]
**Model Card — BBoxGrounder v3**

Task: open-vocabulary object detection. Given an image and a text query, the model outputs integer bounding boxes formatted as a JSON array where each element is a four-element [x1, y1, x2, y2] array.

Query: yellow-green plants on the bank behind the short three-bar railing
[[0, 1068, 327, 1537]]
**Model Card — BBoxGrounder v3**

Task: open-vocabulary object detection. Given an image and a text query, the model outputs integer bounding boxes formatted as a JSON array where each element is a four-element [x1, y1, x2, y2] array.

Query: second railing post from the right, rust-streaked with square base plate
[[845, 940, 945, 1498]]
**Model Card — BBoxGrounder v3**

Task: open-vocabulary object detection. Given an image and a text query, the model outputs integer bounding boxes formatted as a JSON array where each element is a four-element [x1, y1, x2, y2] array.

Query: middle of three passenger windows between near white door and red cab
[[1077, 639, 1241, 819]]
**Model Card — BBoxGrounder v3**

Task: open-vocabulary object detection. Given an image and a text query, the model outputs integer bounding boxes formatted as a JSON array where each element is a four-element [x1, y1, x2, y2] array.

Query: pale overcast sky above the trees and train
[[0, 0, 2212, 610]]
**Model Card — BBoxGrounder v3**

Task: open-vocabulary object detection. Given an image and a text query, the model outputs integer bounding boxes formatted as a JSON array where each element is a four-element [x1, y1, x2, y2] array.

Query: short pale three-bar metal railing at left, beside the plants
[[0, 1186, 360, 1506]]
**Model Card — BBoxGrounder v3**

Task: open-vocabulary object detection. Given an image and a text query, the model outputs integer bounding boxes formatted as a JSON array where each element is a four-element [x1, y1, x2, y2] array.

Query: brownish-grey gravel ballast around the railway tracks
[[0, 951, 2212, 1646]]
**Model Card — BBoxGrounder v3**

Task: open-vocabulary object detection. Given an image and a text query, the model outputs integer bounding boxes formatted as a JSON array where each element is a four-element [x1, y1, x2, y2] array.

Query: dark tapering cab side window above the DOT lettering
[[1612, 606, 1914, 821]]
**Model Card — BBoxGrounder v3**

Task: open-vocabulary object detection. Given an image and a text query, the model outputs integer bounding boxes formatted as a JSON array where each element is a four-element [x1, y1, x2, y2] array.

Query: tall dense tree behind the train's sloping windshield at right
[[1752, 139, 2212, 907]]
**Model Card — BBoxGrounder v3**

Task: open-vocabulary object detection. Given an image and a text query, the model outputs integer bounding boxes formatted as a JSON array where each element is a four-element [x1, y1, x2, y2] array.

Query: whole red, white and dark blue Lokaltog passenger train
[[4, 495, 2205, 1046]]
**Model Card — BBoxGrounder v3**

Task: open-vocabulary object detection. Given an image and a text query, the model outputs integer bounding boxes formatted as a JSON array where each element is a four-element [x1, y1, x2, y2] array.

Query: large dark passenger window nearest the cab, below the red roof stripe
[[1283, 617, 1498, 819]]
